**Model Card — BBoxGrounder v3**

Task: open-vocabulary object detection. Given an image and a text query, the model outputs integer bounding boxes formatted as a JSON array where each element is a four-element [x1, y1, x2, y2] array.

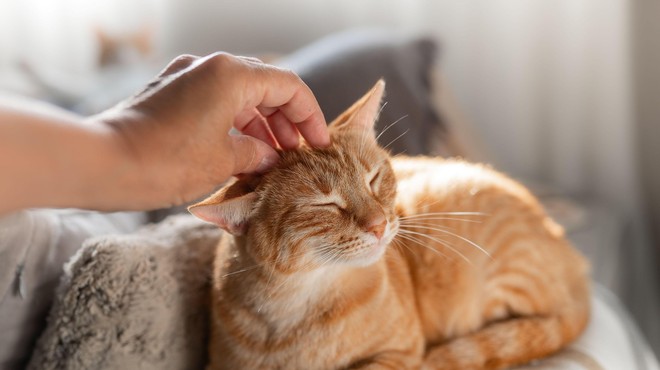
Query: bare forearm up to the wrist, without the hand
[[0, 97, 142, 214]]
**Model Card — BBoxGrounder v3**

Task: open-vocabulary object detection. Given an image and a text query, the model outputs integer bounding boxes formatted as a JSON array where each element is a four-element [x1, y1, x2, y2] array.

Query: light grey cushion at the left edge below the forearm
[[0, 209, 145, 369]]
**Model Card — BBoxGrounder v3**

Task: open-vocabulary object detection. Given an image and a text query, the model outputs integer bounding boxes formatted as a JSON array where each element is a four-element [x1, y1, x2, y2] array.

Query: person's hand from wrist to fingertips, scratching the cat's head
[[90, 53, 330, 208]]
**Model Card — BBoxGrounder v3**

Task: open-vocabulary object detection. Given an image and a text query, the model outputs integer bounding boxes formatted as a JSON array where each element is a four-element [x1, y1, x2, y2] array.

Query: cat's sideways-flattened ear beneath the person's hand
[[188, 177, 258, 235]]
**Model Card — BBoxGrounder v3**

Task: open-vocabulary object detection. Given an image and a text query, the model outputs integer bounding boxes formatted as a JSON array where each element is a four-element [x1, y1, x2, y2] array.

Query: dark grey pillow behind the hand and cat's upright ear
[[276, 30, 447, 155]]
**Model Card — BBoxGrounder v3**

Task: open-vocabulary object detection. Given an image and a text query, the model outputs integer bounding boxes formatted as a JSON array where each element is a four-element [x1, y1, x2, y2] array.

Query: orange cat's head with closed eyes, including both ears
[[189, 80, 398, 270]]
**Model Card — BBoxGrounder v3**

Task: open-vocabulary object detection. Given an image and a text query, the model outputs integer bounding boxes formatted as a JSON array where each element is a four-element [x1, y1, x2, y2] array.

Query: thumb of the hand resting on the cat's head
[[230, 135, 280, 175]]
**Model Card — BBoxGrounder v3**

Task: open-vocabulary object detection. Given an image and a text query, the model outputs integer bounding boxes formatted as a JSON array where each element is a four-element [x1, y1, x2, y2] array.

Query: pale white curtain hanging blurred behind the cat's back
[[422, 0, 639, 213]]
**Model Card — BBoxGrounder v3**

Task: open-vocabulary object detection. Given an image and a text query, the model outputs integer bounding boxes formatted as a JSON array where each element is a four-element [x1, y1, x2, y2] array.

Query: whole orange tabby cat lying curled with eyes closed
[[190, 81, 589, 370]]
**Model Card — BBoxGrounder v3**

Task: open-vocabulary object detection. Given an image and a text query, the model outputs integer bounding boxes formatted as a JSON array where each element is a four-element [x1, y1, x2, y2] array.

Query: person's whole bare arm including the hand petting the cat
[[0, 53, 329, 214]]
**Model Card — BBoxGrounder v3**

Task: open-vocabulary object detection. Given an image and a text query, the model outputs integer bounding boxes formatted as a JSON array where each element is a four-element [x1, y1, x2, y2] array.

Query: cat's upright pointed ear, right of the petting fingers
[[330, 79, 385, 133]]
